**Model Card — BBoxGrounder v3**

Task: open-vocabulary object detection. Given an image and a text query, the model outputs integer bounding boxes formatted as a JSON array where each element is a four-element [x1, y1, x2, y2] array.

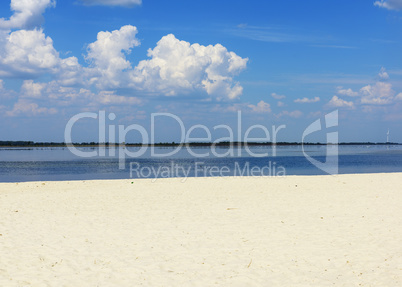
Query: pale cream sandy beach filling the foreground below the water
[[0, 174, 402, 287]]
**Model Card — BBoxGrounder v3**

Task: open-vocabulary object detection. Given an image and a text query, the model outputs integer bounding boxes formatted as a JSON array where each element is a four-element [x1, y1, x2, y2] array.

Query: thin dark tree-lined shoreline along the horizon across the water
[[0, 141, 402, 148]]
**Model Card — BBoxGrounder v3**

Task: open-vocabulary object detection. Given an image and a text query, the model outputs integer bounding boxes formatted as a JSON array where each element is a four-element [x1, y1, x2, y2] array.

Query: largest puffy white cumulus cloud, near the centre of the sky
[[132, 34, 248, 99]]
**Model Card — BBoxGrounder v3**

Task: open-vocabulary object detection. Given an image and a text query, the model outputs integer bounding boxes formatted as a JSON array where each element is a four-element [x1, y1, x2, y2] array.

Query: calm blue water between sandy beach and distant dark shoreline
[[0, 146, 402, 182]]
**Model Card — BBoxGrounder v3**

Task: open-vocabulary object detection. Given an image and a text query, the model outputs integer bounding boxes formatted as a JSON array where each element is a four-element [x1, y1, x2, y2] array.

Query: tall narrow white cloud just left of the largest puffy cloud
[[86, 25, 140, 88]]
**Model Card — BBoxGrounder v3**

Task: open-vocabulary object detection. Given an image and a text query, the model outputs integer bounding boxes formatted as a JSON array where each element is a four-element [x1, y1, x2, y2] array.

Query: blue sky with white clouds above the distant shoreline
[[0, 0, 402, 143]]
